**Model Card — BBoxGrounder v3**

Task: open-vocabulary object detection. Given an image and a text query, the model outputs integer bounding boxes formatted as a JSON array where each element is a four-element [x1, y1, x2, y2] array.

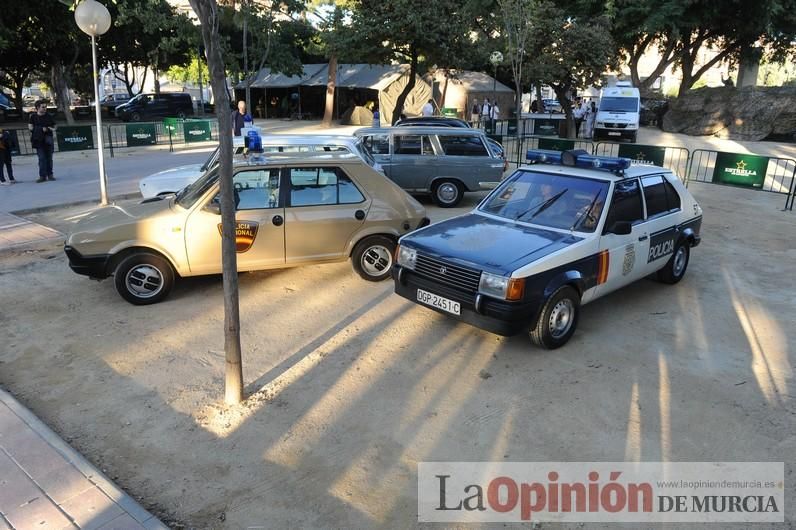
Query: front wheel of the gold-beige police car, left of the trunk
[[114, 252, 174, 305]]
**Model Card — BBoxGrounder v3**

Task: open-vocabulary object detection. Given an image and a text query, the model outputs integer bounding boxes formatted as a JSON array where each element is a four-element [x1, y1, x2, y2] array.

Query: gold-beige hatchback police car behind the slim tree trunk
[[64, 152, 429, 305]]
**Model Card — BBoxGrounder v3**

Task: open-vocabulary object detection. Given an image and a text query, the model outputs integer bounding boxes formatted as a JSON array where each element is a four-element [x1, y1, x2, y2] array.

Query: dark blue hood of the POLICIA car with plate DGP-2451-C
[[401, 213, 583, 276]]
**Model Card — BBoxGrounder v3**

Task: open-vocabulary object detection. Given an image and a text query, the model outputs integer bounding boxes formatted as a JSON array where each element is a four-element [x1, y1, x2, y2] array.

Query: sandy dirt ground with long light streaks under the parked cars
[[0, 183, 796, 528]]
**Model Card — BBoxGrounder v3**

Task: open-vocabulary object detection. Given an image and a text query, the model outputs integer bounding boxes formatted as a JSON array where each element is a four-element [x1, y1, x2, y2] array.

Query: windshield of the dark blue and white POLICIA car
[[478, 170, 608, 232]]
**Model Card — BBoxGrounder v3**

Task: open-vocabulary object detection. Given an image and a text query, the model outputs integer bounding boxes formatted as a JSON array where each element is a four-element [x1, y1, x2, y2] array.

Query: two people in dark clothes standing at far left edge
[[0, 101, 56, 186]]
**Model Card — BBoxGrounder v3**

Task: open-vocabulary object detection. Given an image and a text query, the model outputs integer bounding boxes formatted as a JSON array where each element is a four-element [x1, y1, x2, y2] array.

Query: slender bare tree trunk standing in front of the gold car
[[190, 0, 243, 405]]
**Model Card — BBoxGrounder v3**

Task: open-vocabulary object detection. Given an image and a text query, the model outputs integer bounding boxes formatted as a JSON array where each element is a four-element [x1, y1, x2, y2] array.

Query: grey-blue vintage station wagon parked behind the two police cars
[[355, 127, 504, 208]]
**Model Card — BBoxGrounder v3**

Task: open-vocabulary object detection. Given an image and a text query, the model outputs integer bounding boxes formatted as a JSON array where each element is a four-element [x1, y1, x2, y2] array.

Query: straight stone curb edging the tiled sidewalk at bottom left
[[0, 388, 168, 530]]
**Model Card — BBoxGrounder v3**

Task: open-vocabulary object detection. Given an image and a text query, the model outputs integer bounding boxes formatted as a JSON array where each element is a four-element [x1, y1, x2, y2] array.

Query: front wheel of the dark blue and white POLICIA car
[[529, 285, 580, 350]]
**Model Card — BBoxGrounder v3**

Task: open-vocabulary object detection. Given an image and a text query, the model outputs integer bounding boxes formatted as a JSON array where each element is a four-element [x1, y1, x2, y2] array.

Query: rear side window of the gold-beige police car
[[289, 167, 365, 206]]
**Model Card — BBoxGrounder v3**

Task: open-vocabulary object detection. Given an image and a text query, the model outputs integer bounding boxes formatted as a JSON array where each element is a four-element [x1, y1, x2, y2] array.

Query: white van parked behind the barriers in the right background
[[593, 81, 641, 142]]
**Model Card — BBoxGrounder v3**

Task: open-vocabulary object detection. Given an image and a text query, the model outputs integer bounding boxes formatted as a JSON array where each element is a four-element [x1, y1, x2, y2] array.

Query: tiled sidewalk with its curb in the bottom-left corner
[[0, 389, 167, 530]]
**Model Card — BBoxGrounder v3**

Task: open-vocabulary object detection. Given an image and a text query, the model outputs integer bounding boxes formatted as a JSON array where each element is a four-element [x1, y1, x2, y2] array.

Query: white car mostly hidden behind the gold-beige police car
[[138, 134, 382, 198]]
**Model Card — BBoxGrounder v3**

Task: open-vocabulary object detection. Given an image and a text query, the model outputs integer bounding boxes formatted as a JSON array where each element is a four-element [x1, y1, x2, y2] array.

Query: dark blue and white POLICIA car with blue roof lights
[[392, 150, 702, 349]]
